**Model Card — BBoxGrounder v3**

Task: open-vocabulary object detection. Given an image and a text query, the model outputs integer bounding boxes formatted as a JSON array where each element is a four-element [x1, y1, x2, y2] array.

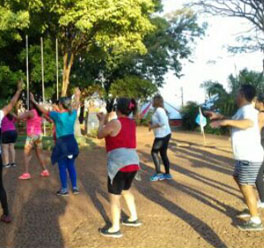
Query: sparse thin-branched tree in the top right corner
[[190, 0, 264, 55]]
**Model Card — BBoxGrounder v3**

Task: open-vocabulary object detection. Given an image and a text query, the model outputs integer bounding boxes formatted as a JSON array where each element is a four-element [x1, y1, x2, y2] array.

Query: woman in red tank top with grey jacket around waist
[[97, 98, 141, 238]]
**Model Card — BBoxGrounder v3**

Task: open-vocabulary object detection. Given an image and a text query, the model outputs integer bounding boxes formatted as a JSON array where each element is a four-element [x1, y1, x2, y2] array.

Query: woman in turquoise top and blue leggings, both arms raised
[[31, 89, 81, 196]]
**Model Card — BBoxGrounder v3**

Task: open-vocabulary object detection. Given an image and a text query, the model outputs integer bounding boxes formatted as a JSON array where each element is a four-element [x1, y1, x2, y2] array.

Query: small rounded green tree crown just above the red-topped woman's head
[[110, 76, 158, 100]]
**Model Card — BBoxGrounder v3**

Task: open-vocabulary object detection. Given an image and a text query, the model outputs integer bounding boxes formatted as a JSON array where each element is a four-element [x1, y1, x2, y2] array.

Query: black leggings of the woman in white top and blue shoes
[[151, 134, 171, 174]]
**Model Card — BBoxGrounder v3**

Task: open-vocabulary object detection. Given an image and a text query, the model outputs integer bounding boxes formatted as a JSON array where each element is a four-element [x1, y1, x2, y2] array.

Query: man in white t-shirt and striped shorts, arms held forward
[[209, 85, 264, 231]]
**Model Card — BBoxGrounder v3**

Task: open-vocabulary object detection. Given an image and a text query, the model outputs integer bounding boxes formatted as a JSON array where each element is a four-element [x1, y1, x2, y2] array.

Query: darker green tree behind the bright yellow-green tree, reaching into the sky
[[71, 9, 206, 100]]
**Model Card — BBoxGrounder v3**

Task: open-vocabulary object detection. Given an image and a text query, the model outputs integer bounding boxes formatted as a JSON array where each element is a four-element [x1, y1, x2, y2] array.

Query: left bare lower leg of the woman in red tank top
[[109, 194, 121, 232]]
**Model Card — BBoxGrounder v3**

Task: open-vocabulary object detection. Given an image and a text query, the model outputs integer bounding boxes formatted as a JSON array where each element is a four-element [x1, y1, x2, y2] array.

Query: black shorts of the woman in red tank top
[[107, 171, 137, 195]]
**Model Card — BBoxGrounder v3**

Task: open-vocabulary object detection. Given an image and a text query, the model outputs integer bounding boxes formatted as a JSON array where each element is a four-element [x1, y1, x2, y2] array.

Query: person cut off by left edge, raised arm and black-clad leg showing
[[0, 82, 22, 223]]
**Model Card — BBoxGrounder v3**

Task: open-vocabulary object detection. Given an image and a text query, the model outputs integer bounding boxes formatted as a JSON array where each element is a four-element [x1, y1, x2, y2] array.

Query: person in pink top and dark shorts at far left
[[1, 114, 17, 168]]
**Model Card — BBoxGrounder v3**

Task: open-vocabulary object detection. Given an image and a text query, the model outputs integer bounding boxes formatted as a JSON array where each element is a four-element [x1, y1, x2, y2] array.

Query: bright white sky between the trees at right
[[160, 0, 263, 107]]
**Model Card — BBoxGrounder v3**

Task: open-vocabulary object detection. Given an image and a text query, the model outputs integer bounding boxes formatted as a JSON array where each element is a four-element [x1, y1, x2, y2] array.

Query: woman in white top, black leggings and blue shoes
[[149, 95, 172, 182]]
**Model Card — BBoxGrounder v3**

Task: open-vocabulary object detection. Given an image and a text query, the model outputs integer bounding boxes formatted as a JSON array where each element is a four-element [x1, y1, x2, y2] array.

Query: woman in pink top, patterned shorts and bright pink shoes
[[17, 101, 49, 180]]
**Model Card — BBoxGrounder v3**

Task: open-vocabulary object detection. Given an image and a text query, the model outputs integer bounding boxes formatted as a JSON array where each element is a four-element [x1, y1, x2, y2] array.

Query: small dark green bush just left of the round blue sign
[[181, 102, 199, 131]]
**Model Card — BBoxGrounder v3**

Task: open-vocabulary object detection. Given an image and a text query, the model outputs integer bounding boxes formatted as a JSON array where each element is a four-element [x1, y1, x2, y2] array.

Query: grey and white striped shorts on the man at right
[[233, 160, 262, 185]]
